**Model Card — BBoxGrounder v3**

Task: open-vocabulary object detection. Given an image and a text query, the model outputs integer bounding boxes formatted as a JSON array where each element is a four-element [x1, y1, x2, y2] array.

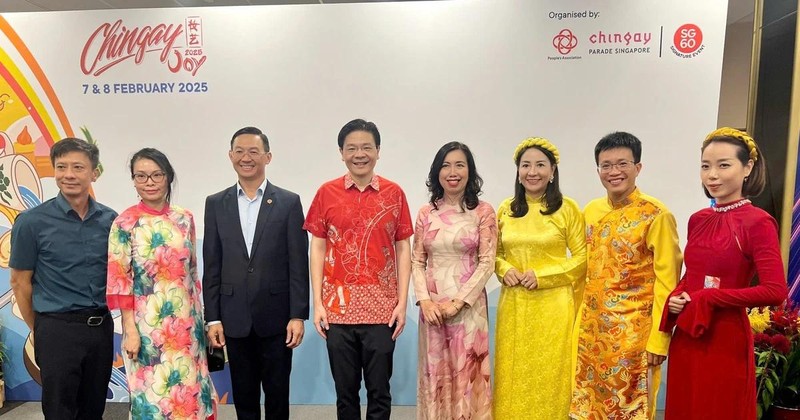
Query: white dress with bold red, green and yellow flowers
[[106, 203, 217, 419]]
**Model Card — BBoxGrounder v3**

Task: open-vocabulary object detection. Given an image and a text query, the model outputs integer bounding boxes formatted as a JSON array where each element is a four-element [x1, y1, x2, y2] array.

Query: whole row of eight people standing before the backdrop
[[10, 119, 787, 420]]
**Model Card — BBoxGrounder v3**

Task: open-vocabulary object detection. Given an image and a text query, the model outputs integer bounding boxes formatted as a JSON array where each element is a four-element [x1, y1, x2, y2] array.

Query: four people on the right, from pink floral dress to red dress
[[412, 128, 787, 420]]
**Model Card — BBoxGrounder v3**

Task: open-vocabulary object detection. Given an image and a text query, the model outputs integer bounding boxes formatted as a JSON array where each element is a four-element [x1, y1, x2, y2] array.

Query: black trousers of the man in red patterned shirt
[[327, 324, 395, 420]]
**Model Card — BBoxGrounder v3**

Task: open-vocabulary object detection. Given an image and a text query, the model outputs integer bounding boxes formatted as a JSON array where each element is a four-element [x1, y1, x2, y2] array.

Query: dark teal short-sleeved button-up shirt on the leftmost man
[[9, 193, 117, 312]]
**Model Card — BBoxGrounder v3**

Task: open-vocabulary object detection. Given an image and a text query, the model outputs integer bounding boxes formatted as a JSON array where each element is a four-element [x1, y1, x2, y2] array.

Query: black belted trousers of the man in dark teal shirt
[[33, 310, 114, 420]]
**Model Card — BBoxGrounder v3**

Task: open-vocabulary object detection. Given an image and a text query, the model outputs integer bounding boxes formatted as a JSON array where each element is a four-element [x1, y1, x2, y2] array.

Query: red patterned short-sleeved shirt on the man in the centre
[[303, 174, 414, 324]]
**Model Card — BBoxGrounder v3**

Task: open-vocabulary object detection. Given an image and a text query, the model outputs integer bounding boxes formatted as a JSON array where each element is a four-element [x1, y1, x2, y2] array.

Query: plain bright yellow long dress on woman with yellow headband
[[493, 197, 586, 420]]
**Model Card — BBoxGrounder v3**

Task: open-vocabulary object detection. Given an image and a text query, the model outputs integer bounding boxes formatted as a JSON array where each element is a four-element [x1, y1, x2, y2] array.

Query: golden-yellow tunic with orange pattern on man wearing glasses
[[570, 189, 683, 420]]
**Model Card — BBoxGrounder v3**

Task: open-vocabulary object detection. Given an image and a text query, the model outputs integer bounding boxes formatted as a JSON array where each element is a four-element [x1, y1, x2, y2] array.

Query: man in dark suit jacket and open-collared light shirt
[[203, 127, 309, 419]]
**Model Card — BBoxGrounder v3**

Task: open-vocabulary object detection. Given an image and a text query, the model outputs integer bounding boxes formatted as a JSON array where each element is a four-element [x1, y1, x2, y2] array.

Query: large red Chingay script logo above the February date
[[81, 17, 206, 76]]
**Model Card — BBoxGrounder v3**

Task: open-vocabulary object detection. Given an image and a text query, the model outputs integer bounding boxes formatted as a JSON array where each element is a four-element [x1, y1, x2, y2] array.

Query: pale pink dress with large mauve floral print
[[412, 201, 497, 420]]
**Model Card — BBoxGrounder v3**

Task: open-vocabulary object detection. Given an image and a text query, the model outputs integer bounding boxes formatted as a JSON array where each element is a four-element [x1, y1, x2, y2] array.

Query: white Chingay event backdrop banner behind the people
[[0, 0, 727, 404]]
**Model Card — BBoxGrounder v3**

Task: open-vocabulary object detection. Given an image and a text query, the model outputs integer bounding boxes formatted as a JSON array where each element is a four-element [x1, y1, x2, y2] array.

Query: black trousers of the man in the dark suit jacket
[[225, 331, 292, 420]]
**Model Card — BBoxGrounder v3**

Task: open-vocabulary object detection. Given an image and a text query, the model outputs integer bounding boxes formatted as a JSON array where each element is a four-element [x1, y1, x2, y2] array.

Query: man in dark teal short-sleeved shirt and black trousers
[[9, 138, 117, 420]]
